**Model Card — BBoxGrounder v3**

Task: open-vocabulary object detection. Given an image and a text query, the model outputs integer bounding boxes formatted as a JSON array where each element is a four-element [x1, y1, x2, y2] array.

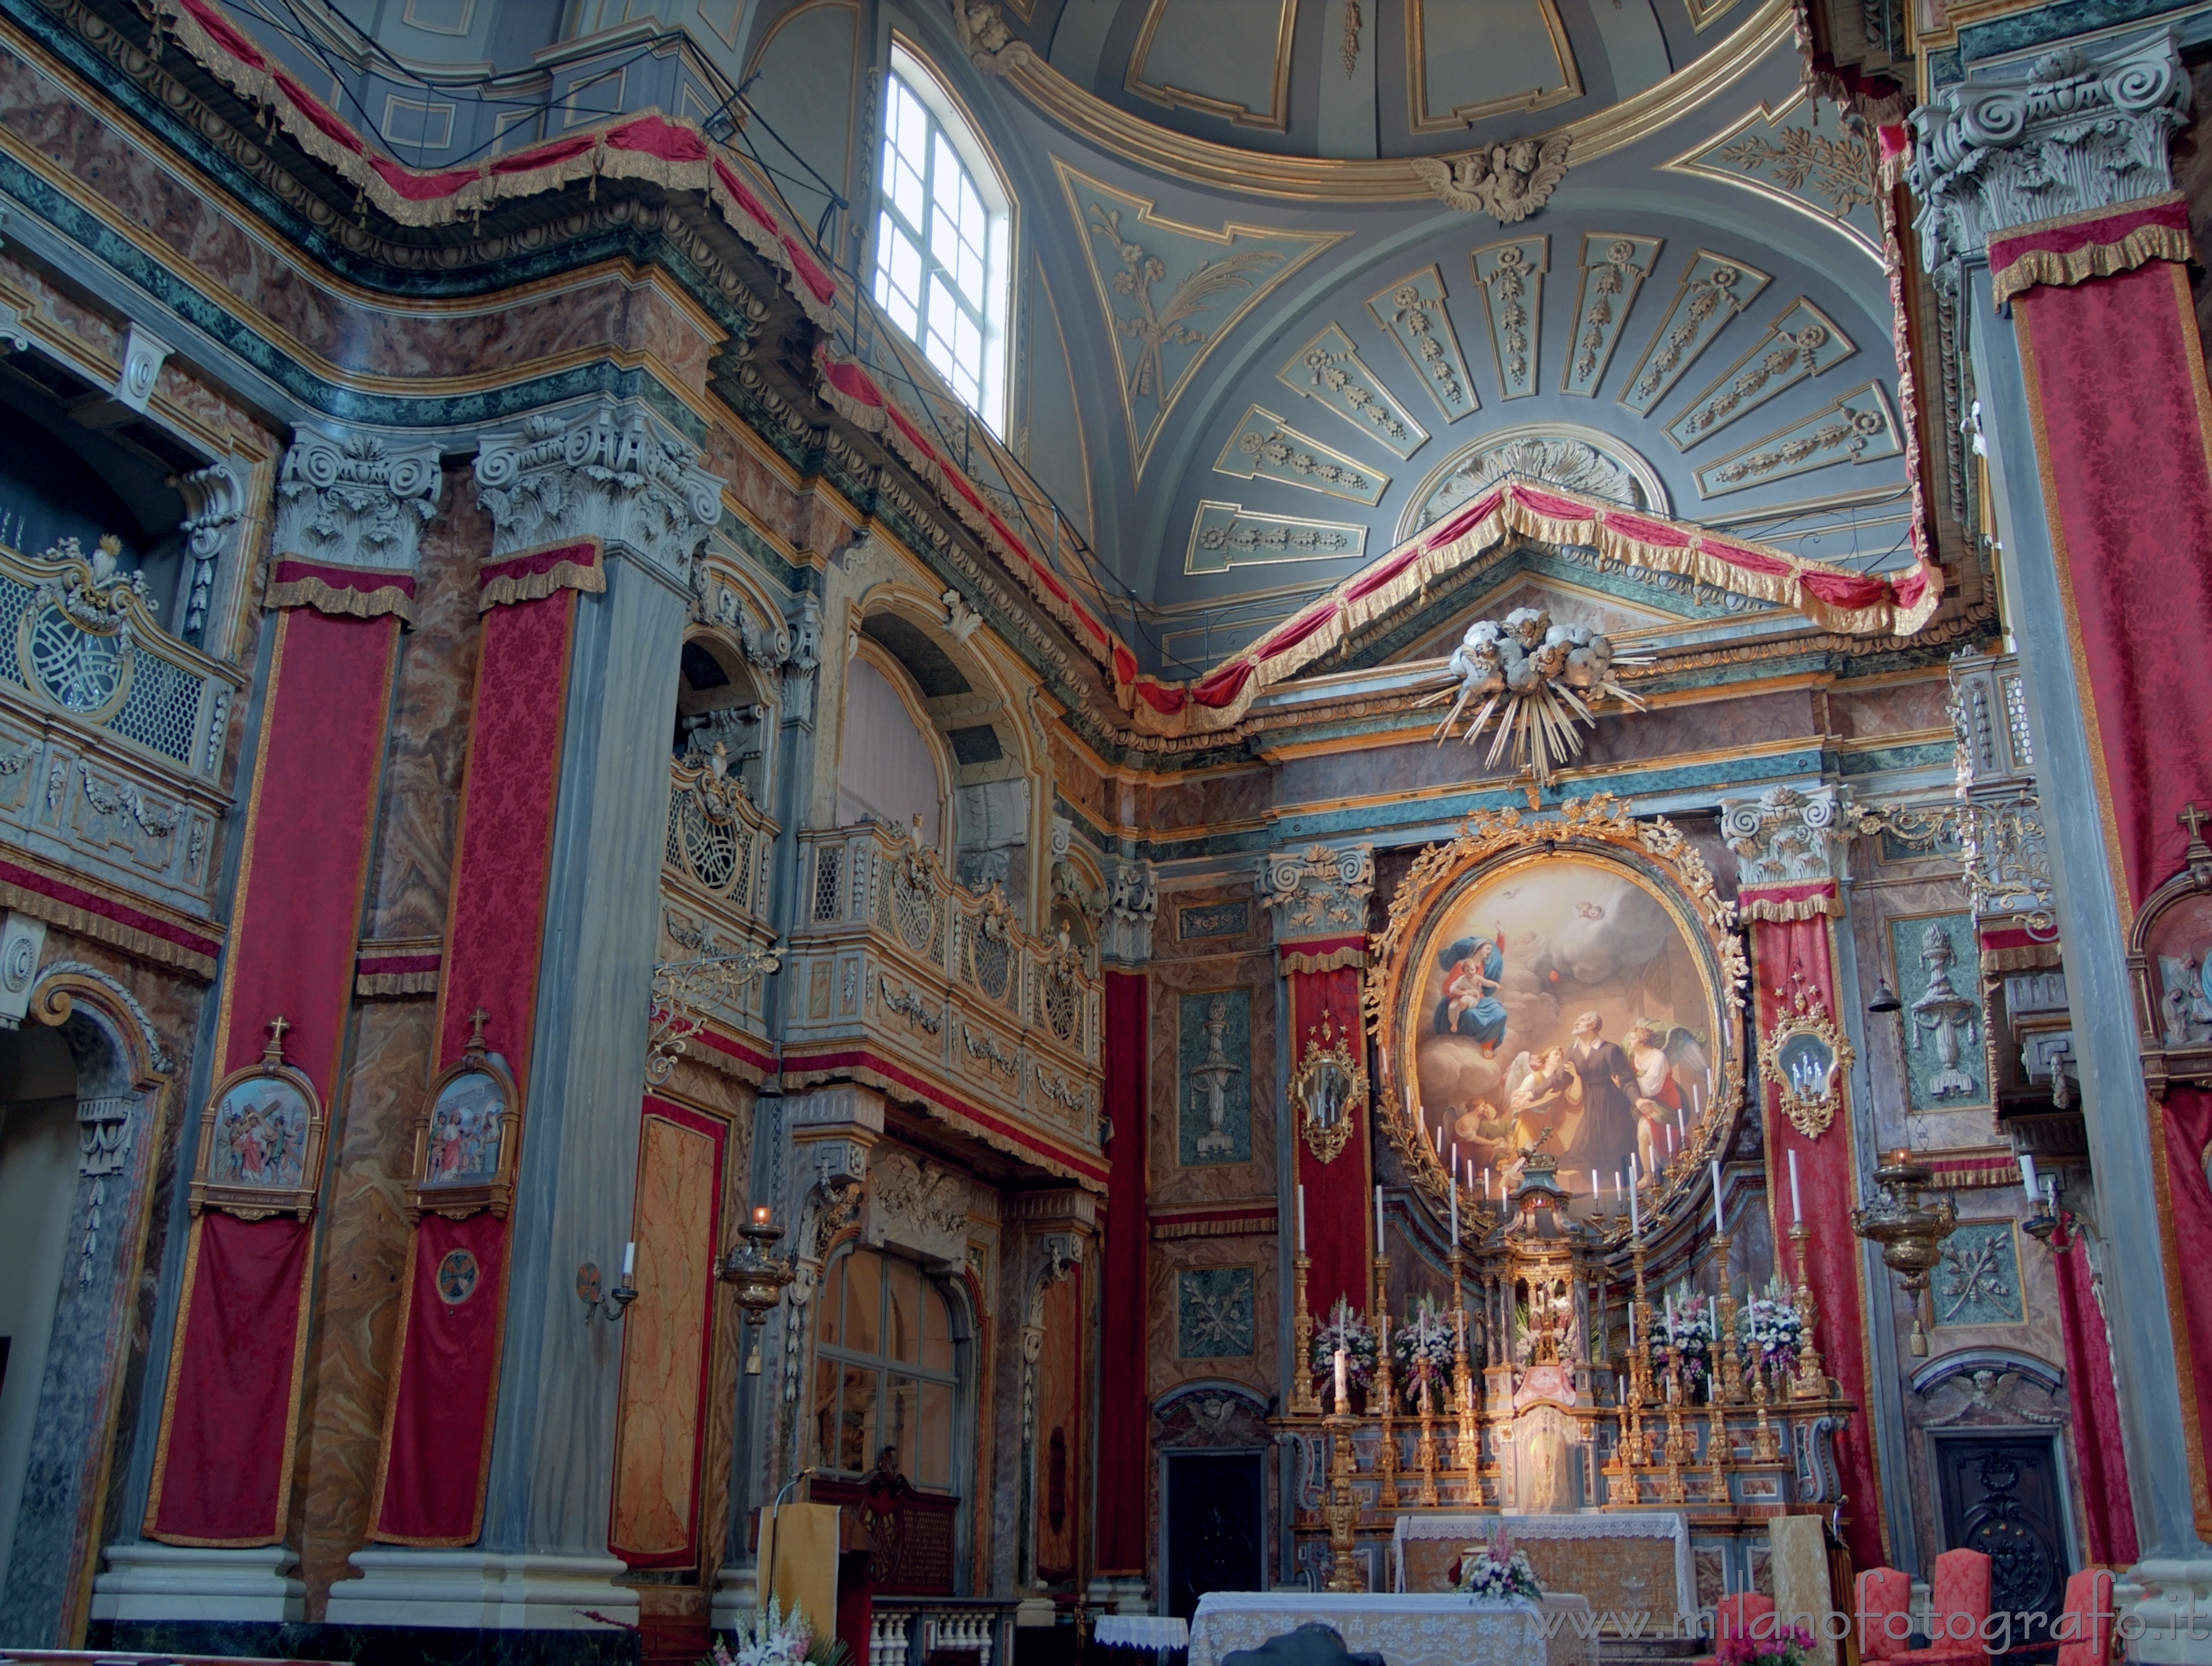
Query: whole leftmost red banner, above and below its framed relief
[[146, 609, 400, 1545]]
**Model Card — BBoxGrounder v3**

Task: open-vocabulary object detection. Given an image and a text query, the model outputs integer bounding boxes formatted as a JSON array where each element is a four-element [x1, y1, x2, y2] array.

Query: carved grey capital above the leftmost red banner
[[269, 434, 445, 571]]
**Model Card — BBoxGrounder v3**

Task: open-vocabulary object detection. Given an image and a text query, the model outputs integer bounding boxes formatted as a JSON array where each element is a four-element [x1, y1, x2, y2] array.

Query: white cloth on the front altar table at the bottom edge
[[1190, 1591, 1597, 1666]]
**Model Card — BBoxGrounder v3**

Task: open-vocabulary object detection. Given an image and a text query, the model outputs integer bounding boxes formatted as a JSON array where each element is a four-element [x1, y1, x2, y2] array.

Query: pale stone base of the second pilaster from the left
[[325, 1545, 637, 1631]]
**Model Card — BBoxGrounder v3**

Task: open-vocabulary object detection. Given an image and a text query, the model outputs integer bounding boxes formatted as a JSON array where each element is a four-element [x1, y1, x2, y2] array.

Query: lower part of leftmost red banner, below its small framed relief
[[146, 1210, 312, 1545]]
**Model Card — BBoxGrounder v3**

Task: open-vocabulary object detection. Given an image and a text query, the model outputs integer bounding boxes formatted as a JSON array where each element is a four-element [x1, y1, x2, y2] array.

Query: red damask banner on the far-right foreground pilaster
[[2017, 231, 2212, 1524]]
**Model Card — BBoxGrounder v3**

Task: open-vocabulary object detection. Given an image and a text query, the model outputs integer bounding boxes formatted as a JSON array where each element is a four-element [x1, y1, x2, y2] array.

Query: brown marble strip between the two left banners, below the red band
[[294, 998, 436, 1620]]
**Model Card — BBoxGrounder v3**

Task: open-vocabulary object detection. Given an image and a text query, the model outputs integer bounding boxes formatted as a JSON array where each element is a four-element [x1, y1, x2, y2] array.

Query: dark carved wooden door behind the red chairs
[[1936, 1433, 2073, 1660]]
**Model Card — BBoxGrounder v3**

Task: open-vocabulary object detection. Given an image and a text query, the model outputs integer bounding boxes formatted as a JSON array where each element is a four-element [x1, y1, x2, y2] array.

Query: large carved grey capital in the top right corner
[[1911, 33, 2190, 272]]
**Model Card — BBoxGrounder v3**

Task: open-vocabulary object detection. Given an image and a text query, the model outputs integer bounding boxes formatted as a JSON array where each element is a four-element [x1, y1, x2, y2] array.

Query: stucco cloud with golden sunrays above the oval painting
[[1413, 609, 1646, 786]]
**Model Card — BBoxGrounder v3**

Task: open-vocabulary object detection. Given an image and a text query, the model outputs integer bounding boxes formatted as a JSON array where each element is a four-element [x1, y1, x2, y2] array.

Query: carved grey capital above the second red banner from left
[[475, 403, 721, 588]]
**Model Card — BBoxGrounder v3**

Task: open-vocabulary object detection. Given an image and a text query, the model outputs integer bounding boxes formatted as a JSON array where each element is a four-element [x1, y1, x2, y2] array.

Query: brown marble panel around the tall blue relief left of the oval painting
[[1148, 942, 1283, 1208]]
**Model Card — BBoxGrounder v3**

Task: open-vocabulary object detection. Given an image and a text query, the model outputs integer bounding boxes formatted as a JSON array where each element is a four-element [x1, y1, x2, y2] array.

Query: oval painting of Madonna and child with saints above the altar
[[1413, 856, 1714, 1212]]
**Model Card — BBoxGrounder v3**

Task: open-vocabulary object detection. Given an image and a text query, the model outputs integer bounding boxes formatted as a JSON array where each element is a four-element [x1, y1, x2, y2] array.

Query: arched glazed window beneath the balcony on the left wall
[[814, 1250, 958, 1494]]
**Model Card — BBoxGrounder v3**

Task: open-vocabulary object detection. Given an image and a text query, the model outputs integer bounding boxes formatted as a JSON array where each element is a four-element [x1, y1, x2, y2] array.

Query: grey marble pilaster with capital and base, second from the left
[[330, 403, 721, 1631]]
